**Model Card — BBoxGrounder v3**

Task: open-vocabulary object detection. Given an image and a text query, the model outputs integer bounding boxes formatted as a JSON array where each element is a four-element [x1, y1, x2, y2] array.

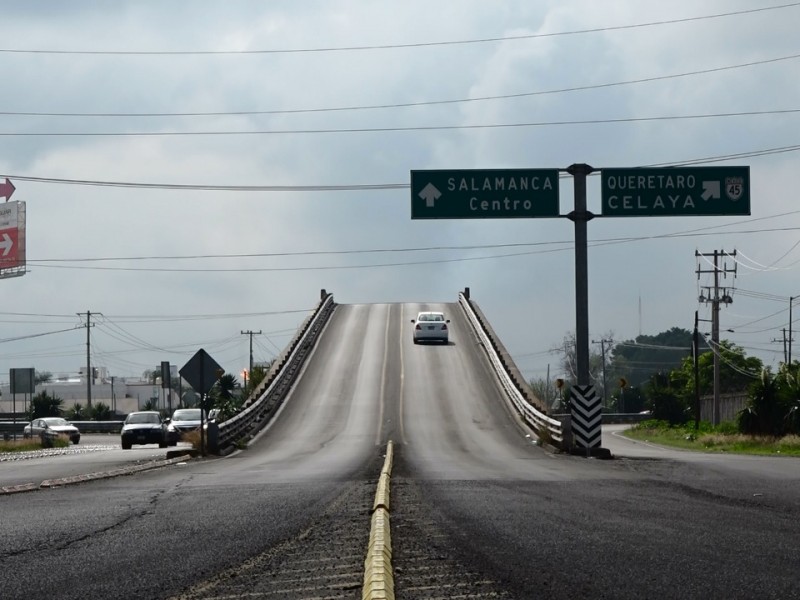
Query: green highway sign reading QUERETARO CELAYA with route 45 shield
[[601, 167, 750, 217]]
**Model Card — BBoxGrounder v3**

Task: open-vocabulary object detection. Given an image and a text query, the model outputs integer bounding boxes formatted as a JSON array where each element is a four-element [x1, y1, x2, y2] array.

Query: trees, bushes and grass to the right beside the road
[[529, 327, 800, 456]]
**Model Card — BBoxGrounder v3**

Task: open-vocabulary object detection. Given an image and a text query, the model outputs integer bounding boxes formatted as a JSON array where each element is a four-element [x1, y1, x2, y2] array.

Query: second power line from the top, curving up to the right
[[0, 54, 800, 118]]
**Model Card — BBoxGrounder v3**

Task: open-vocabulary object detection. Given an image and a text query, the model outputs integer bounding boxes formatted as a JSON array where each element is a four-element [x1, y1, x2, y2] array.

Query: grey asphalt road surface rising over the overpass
[[0, 304, 800, 600]]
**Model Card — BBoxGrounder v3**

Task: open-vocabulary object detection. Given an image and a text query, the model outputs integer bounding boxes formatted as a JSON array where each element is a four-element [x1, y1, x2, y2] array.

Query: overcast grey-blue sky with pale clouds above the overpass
[[0, 0, 800, 382]]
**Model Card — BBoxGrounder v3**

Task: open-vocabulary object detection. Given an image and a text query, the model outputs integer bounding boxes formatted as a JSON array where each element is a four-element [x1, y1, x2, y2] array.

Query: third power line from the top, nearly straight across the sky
[[0, 108, 800, 137]]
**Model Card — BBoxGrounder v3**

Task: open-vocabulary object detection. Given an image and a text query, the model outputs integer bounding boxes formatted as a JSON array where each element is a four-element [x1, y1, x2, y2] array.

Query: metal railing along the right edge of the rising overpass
[[458, 290, 569, 448]]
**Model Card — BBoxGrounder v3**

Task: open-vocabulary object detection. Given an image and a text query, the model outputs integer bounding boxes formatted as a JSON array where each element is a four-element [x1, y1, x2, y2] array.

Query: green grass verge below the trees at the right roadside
[[624, 421, 800, 456]]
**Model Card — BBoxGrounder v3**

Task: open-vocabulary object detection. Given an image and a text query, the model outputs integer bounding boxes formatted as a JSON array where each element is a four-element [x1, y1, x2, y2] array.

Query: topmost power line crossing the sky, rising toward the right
[[0, 2, 800, 56]]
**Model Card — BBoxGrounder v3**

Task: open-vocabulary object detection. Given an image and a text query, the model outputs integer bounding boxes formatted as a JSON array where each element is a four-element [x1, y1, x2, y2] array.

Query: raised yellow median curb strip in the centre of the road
[[361, 441, 394, 600]]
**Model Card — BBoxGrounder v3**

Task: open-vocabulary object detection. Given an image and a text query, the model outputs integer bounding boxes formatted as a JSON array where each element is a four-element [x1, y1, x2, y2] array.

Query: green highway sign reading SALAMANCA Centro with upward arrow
[[411, 169, 559, 219]]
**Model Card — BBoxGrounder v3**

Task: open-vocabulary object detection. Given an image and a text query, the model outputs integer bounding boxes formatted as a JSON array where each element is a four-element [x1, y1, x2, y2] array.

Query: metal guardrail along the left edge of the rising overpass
[[212, 290, 336, 452]]
